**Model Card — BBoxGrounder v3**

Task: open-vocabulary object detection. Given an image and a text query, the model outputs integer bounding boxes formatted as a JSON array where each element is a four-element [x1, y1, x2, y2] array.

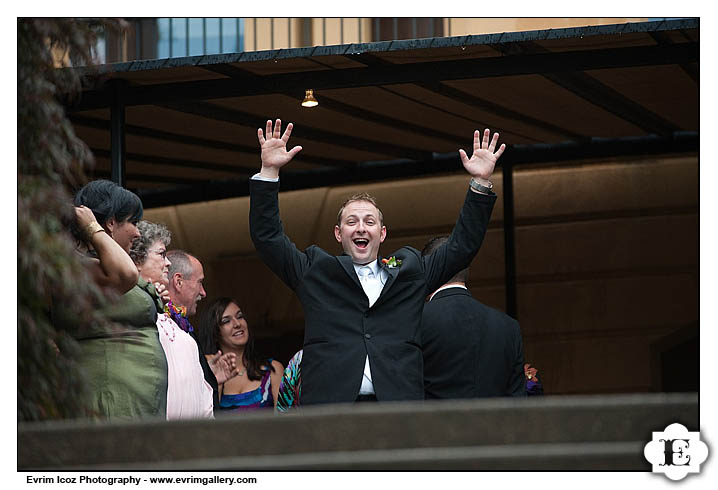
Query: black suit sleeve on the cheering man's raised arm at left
[[249, 180, 309, 289]]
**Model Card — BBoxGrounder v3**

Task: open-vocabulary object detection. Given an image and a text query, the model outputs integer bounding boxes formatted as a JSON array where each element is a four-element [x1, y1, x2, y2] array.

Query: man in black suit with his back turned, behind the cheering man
[[420, 237, 526, 399]]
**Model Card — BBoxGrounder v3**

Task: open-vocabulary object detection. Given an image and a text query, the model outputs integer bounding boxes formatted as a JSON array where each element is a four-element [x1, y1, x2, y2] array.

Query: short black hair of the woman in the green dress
[[73, 180, 143, 241]]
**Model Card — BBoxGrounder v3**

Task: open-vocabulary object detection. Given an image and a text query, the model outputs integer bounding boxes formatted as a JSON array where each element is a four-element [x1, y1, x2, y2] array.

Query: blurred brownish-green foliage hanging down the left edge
[[17, 19, 124, 421]]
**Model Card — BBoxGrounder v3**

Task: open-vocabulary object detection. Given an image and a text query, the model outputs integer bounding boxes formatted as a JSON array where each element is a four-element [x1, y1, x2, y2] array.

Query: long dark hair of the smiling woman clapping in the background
[[197, 297, 274, 381]]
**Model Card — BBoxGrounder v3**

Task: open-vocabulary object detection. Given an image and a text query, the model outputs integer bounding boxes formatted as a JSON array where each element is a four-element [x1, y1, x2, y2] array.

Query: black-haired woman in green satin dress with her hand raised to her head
[[54, 180, 167, 420]]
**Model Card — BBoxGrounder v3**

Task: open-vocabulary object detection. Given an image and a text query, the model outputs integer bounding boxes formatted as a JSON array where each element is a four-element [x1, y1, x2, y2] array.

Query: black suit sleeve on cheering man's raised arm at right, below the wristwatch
[[423, 189, 496, 294]]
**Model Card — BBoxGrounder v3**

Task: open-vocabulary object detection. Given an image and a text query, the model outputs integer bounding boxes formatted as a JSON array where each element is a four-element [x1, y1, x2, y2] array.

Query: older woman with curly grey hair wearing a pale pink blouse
[[130, 221, 214, 420]]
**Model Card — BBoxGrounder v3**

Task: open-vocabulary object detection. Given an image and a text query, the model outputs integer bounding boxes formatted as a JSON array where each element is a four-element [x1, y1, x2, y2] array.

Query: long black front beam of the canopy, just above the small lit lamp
[[68, 42, 699, 112]]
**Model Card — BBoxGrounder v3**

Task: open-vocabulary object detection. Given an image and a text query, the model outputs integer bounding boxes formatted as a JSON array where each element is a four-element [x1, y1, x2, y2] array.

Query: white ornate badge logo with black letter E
[[643, 424, 708, 480]]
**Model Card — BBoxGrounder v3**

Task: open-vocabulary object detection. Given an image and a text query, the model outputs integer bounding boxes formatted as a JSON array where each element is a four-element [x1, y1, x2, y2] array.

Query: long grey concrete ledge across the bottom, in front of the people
[[18, 394, 699, 470]]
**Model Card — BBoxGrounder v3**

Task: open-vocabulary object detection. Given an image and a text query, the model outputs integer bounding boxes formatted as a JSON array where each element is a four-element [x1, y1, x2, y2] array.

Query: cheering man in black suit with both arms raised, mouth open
[[249, 119, 505, 405]]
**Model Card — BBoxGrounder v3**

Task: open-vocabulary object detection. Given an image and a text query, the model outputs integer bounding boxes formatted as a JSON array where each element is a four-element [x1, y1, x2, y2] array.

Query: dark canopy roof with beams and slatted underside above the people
[[68, 19, 699, 207]]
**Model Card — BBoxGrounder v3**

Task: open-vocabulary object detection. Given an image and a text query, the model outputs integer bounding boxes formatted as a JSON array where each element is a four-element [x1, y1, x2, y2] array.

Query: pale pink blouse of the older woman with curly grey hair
[[157, 314, 214, 420]]
